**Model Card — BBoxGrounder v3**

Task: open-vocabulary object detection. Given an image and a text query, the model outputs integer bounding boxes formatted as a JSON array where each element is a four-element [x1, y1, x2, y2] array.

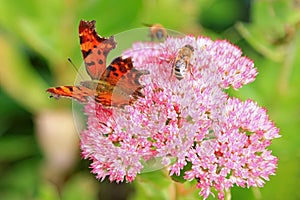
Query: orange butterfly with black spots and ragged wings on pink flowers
[[47, 20, 149, 107]]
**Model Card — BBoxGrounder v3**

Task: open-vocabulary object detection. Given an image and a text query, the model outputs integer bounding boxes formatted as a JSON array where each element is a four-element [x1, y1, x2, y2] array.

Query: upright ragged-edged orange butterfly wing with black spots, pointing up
[[79, 20, 117, 80]]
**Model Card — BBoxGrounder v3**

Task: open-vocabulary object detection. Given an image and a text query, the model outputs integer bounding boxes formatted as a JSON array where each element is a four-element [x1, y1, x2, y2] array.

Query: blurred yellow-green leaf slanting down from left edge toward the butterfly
[[0, 35, 49, 112]]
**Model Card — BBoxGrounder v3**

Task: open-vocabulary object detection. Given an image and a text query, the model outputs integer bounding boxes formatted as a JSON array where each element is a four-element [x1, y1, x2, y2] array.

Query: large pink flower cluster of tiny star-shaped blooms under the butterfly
[[81, 36, 279, 199]]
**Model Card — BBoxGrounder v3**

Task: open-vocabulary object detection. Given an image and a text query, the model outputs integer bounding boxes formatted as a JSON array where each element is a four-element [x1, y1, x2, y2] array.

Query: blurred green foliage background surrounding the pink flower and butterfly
[[0, 0, 300, 200]]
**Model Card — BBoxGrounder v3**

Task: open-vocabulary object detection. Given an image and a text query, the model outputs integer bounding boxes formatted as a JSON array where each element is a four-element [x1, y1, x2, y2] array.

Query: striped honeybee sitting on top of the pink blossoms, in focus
[[172, 44, 194, 80]]
